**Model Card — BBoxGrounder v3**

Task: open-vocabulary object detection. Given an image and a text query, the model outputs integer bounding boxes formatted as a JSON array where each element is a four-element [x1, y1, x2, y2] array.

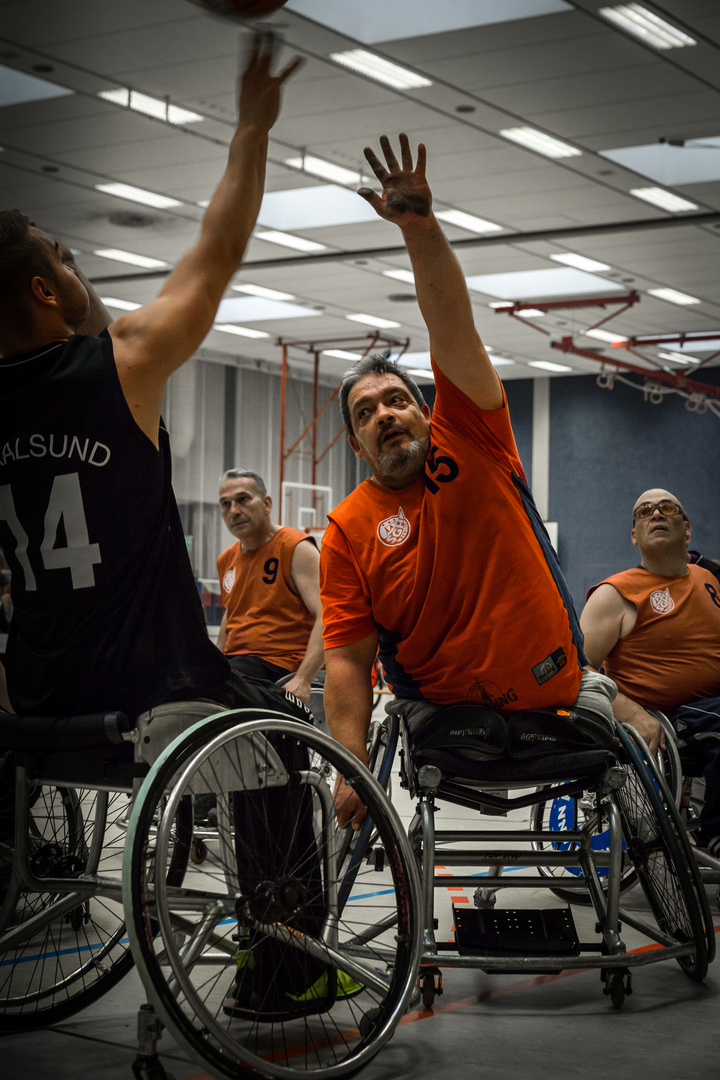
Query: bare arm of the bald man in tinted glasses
[[580, 584, 665, 754]]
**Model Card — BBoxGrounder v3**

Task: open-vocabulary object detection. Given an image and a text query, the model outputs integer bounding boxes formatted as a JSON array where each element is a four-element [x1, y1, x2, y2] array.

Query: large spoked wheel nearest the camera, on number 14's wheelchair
[[124, 710, 421, 1080]]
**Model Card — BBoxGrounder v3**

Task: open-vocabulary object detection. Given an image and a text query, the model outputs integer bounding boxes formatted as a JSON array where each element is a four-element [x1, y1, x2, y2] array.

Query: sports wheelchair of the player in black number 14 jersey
[[0, 702, 422, 1080]]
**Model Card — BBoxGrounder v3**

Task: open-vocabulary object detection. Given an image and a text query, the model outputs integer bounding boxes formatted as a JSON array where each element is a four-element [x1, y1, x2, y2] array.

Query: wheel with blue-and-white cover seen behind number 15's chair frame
[[530, 788, 638, 906]]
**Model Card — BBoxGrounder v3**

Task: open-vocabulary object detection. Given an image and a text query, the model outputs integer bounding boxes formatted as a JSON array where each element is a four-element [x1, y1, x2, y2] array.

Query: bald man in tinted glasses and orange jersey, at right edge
[[581, 488, 720, 858]]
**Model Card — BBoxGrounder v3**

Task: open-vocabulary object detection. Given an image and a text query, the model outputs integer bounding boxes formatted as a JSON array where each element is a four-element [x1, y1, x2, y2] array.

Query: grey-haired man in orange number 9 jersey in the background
[[217, 469, 323, 704]]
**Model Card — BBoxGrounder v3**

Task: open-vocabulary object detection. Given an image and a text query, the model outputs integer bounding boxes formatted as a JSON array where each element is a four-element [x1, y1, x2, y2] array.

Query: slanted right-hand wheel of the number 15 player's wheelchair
[[613, 725, 715, 982]]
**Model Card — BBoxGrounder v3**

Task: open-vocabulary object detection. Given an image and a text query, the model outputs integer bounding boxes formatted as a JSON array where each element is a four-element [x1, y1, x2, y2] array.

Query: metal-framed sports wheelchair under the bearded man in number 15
[[357, 706, 716, 1009]]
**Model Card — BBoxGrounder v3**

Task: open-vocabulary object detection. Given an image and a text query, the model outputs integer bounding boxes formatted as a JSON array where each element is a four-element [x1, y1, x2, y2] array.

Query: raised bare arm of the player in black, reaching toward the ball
[[109, 35, 301, 445]]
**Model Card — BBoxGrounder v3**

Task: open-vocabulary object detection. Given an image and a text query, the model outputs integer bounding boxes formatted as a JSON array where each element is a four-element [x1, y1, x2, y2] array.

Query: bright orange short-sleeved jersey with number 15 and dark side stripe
[[321, 368, 585, 712]]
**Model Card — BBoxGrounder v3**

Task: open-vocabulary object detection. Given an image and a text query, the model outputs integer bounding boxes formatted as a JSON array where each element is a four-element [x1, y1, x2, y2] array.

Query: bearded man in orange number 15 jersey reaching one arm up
[[321, 135, 614, 826]]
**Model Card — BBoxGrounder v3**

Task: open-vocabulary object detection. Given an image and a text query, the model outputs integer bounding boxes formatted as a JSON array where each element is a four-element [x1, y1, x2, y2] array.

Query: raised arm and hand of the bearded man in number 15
[[358, 135, 503, 409]]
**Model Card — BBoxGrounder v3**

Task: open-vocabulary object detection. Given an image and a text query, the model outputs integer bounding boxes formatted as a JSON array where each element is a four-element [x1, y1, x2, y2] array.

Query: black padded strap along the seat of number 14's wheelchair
[[0, 713, 135, 753]]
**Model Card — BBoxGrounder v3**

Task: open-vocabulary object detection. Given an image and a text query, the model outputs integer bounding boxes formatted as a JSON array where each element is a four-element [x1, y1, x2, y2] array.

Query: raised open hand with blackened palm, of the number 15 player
[[357, 135, 433, 228]]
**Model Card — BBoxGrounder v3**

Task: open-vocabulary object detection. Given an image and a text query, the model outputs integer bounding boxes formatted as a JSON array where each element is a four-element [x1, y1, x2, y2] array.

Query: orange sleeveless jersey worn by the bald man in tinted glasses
[[587, 566, 720, 710]]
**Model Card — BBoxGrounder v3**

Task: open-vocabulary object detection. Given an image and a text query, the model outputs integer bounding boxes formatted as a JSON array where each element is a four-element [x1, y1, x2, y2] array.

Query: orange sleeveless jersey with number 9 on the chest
[[217, 526, 315, 671]]
